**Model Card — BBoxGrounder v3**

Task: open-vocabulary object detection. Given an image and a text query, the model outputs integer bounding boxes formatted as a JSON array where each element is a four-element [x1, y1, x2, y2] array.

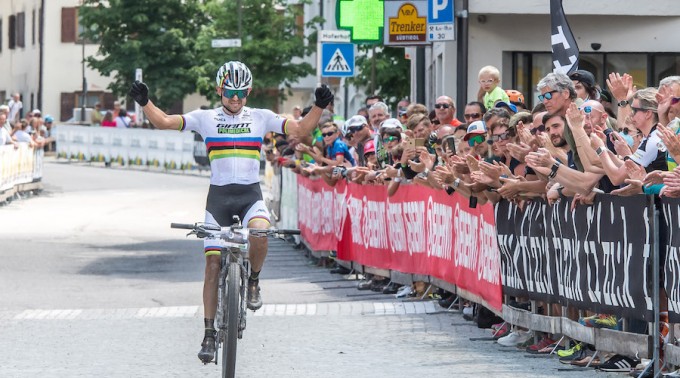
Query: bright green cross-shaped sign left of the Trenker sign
[[335, 0, 385, 43]]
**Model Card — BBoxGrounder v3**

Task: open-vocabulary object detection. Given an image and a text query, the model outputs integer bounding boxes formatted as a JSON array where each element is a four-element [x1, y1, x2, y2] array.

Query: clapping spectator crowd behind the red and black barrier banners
[[264, 66, 680, 375]]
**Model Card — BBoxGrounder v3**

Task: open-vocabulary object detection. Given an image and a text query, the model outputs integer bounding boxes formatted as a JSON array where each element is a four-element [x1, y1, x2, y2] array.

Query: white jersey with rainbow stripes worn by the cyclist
[[180, 106, 288, 185]]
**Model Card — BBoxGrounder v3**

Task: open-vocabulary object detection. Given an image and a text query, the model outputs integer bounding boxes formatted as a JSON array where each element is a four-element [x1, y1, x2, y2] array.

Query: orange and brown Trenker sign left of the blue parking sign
[[384, 0, 432, 46]]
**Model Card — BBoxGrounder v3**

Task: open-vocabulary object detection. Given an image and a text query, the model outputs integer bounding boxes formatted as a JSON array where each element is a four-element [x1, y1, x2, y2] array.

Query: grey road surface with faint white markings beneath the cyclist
[[0, 159, 606, 378]]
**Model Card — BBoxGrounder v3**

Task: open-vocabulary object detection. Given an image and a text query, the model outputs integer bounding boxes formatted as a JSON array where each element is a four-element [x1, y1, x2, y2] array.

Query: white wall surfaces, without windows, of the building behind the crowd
[[420, 0, 680, 107]]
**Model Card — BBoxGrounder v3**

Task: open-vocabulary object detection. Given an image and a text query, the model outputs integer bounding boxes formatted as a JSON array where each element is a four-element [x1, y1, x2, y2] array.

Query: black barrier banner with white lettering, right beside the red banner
[[496, 195, 656, 321]]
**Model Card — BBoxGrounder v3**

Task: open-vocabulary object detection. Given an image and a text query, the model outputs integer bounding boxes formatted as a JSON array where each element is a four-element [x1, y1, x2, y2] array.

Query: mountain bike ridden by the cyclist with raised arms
[[170, 217, 300, 378]]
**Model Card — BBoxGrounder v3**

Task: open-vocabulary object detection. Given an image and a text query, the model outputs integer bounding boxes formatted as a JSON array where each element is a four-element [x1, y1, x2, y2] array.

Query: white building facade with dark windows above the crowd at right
[[418, 0, 680, 117]]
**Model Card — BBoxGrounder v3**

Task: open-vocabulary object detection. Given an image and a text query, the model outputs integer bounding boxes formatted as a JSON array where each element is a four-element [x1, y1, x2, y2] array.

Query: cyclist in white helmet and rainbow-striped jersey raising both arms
[[129, 61, 333, 363]]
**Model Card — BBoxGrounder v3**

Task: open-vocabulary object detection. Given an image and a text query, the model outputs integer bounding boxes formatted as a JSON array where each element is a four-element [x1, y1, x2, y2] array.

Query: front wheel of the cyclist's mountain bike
[[222, 262, 241, 378]]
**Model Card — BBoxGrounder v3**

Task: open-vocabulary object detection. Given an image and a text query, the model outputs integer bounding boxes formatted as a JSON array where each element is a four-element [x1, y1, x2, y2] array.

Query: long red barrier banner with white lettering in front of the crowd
[[298, 178, 502, 311]]
